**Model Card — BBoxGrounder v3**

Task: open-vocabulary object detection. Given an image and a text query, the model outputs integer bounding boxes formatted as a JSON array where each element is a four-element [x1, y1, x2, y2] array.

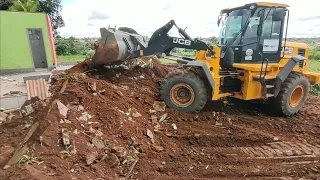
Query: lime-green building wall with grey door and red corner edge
[[0, 11, 57, 74]]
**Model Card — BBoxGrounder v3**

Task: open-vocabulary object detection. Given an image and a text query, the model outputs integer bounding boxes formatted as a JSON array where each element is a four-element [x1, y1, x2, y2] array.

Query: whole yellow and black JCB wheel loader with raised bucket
[[91, 2, 320, 116]]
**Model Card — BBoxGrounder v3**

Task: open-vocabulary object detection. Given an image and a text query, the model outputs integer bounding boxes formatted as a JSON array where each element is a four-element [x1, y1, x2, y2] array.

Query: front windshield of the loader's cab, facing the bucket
[[219, 9, 251, 45]]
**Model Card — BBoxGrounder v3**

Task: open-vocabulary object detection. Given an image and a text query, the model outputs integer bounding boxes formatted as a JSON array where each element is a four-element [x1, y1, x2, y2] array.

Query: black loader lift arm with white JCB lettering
[[128, 20, 214, 58]]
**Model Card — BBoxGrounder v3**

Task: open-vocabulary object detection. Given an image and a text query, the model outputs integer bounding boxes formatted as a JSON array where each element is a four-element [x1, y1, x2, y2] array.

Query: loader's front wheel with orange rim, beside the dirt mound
[[160, 71, 207, 112]]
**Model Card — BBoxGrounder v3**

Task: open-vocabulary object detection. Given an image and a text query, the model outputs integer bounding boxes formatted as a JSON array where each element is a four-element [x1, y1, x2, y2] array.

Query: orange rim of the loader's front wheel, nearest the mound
[[170, 83, 195, 107]]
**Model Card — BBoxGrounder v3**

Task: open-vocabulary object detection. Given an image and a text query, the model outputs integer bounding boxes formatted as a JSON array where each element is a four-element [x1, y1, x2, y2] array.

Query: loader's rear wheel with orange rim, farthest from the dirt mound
[[274, 72, 310, 116]]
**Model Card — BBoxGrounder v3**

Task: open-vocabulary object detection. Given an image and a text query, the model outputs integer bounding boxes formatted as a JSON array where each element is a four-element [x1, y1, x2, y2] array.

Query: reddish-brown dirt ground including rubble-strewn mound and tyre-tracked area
[[0, 58, 320, 180]]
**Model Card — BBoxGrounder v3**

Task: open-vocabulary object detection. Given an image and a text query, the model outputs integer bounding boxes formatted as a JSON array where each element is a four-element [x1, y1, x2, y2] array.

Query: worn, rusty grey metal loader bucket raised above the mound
[[88, 28, 145, 67]]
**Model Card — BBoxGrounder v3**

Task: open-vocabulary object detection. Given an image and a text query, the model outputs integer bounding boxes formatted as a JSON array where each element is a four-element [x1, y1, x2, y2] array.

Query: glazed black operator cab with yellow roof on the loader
[[218, 3, 289, 68]]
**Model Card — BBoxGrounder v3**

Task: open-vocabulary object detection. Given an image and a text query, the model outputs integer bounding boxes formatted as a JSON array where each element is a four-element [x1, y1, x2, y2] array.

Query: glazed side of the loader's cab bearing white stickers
[[241, 8, 284, 64]]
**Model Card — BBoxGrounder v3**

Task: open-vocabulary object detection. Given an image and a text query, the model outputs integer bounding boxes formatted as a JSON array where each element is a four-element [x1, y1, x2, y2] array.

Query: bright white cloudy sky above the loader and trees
[[59, 0, 320, 38]]
